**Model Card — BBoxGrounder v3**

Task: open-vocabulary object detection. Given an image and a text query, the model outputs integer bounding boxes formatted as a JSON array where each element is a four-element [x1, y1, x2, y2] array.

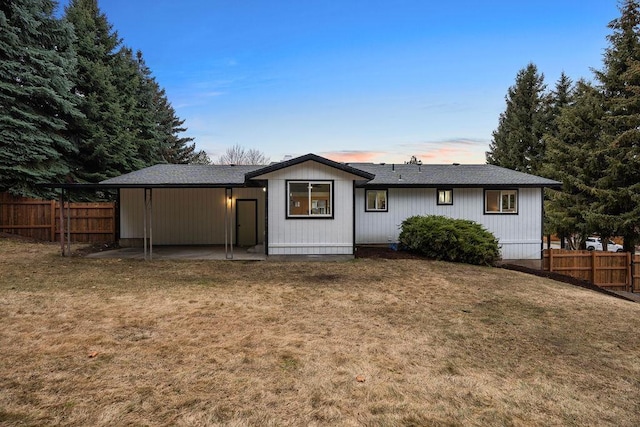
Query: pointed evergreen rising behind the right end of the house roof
[[486, 63, 548, 174]]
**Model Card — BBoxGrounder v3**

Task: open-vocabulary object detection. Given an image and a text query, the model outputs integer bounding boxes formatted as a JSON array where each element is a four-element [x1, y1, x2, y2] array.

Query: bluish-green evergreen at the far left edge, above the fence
[[0, 0, 80, 197]]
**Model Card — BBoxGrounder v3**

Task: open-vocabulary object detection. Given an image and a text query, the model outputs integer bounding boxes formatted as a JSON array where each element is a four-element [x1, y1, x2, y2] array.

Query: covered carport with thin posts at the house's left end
[[47, 164, 267, 259]]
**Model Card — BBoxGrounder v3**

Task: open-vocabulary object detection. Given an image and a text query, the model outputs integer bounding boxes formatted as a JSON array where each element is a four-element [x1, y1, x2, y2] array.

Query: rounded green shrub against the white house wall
[[400, 215, 500, 265]]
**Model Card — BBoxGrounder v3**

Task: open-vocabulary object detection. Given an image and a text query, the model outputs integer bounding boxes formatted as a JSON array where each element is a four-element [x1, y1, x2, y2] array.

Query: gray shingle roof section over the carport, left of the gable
[[100, 164, 264, 186]]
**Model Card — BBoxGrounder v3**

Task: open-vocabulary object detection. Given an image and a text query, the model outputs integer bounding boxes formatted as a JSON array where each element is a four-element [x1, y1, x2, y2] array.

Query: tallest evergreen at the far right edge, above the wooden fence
[[595, 0, 640, 251]]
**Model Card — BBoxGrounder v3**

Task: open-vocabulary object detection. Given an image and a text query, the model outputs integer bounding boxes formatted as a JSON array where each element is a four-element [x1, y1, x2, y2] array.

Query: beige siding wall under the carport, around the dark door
[[120, 188, 265, 246]]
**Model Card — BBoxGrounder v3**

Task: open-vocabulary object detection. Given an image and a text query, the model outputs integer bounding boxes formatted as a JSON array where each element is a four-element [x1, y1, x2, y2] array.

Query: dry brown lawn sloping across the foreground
[[0, 239, 640, 426]]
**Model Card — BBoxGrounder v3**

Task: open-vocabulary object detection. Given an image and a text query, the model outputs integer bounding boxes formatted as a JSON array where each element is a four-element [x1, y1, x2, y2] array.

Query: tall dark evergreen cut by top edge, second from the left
[[65, 0, 143, 182]]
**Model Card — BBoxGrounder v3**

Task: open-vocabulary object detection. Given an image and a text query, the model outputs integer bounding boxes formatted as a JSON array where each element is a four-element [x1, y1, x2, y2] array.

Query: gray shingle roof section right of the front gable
[[349, 163, 561, 187]]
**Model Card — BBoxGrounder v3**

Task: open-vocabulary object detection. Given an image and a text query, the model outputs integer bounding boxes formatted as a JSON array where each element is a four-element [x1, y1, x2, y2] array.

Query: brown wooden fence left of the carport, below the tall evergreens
[[0, 193, 116, 243]]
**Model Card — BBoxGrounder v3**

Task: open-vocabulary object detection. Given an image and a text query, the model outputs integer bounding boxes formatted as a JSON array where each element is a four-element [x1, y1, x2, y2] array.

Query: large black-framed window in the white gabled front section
[[287, 181, 333, 218]]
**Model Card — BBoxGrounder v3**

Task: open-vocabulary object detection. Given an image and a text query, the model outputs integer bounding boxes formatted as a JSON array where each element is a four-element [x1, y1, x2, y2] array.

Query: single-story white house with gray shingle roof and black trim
[[98, 154, 560, 259]]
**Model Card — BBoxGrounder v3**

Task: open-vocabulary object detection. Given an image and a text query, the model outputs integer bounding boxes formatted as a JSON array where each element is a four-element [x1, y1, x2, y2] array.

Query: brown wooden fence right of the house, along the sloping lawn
[[542, 249, 640, 292]]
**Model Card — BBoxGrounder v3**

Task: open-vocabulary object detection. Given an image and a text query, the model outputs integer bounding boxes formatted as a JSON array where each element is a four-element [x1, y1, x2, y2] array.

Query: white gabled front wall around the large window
[[259, 161, 357, 255]]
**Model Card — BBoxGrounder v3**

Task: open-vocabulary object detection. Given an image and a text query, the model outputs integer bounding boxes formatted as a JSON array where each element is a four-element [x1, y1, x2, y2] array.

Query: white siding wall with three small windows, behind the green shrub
[[356, 188, 542, 259]]
